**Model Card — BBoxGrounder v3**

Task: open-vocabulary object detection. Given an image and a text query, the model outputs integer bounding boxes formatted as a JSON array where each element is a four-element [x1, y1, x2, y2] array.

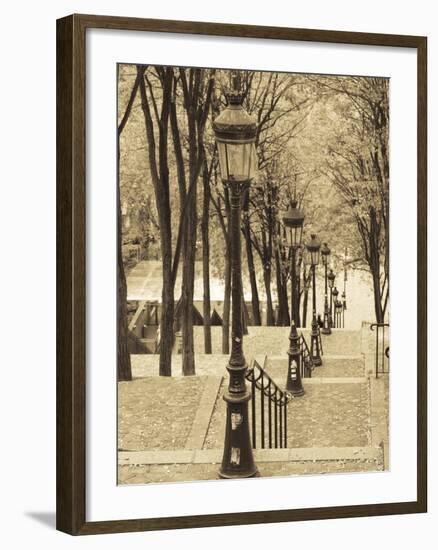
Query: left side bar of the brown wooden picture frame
[[56, 17, 86, 533]]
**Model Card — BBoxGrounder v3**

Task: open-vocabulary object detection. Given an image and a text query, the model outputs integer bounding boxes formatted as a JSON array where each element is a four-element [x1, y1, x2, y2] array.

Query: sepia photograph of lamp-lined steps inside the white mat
[[114, 63, 391, 485]]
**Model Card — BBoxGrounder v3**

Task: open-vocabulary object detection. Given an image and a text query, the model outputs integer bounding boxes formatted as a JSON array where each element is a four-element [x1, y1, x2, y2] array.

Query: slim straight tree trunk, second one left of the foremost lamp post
[[201, 163, 212, 353]]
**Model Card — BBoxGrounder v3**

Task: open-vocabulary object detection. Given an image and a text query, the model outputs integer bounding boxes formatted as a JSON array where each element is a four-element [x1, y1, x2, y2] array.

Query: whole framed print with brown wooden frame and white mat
[[57, 15, 427, 535]]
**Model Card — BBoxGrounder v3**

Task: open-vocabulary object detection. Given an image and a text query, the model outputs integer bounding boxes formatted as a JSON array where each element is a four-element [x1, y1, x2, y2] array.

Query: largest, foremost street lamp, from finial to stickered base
[[213, 77, 257, 478]]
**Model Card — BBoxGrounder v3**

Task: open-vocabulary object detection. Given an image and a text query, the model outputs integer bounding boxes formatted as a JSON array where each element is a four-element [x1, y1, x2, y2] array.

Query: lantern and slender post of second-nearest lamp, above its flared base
[[283, 199, 304, 326]]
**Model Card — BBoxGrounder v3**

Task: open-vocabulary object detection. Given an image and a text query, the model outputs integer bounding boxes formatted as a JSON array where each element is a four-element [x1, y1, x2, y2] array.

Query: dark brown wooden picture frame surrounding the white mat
[[57, 15, 427, 535]]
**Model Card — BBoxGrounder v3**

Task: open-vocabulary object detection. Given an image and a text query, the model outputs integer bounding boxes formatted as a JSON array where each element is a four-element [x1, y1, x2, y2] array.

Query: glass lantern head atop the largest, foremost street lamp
[[213, 90, 257, 184]]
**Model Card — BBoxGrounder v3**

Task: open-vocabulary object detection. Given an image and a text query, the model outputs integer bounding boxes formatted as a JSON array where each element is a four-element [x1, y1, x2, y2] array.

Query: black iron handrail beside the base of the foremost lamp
[[246, 357, 291, 449]]
